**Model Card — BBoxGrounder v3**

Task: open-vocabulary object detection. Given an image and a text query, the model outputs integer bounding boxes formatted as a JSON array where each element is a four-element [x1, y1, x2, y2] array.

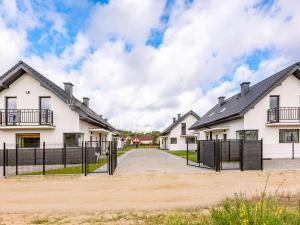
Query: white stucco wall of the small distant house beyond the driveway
[[160, 115, 197, 150]]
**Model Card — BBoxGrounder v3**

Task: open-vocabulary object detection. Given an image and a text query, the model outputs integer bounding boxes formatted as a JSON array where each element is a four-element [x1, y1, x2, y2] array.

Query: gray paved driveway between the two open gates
[[115, 149, 208, 174]]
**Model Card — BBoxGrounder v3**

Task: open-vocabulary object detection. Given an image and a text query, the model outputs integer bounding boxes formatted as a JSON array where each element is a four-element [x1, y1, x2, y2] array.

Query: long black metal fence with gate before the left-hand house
[[0, 141, 117, 177]]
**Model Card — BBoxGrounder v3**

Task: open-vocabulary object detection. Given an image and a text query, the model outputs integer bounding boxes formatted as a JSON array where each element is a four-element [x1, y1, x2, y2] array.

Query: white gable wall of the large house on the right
[[244, 75, 300, 158]]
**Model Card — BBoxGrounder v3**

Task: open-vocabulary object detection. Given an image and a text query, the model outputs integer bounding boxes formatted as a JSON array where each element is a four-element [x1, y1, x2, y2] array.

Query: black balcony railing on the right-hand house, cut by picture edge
[[268, 107, 300, 123]]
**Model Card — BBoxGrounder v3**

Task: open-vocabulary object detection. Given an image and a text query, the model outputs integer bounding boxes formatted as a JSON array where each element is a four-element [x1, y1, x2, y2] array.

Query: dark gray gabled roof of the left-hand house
[[0, 61, 115, 130]]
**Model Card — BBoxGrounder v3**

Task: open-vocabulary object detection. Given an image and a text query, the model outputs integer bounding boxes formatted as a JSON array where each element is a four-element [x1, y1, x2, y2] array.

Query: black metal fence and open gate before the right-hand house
[[187, 139, 263, 171]]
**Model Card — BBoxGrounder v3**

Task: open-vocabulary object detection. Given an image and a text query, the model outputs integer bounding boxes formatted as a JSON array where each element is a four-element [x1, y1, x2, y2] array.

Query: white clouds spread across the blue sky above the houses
[[0, 0, 300, 130]]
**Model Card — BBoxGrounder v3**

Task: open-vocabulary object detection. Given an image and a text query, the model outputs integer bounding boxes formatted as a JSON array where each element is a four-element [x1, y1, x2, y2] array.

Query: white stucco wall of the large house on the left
[[0, 74, 112, 145]]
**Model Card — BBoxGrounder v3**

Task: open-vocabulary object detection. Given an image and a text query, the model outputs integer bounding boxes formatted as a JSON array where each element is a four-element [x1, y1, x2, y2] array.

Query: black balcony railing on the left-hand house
[[0, 109, 53, 126]]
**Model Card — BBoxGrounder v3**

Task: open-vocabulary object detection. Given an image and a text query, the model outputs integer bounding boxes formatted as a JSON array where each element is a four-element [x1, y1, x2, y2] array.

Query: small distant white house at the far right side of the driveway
[[159, 110, 200, 150]]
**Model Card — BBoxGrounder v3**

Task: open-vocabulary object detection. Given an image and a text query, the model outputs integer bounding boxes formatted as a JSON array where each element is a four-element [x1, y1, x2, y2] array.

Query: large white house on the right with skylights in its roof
[[190, 63, 300, 158]]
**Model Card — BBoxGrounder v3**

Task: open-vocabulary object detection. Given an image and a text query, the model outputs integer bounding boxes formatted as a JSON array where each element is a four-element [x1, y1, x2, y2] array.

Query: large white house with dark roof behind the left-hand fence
[[0, 61, 116, 148]]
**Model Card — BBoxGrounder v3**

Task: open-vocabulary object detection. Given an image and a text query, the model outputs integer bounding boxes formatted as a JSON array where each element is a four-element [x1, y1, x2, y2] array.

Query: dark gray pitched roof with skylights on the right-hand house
[[189, 62, 300, 130]]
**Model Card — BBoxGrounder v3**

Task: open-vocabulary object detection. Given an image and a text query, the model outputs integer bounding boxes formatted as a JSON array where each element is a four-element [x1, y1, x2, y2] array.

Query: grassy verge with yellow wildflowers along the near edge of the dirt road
[[24, 194, 300, 225]]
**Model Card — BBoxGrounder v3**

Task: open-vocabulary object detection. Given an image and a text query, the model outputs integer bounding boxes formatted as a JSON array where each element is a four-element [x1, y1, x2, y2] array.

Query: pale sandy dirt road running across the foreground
[[0, 171, 300, 213]]
